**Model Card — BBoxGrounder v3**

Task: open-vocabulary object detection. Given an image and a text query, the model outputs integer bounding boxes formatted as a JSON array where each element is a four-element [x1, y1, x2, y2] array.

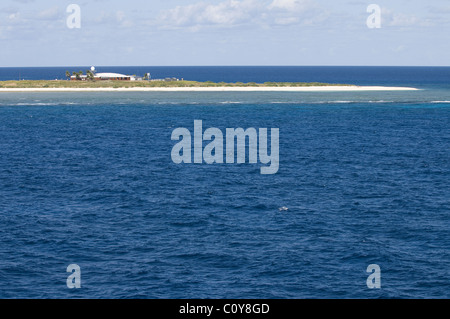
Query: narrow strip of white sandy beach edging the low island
[[0, 86, 418, 93]]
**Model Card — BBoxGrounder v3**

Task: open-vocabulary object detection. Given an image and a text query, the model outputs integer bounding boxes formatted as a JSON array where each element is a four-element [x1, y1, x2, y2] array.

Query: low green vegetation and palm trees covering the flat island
[[0, 79, 347, 89]]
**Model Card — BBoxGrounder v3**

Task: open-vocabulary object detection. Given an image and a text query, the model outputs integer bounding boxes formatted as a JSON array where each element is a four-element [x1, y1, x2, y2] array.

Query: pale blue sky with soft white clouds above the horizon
[[0, 0, 450, 67]]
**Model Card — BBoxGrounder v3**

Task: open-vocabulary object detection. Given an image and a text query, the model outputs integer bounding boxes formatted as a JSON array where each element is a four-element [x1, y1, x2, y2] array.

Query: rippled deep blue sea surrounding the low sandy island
[[0, 67, 450, 299]]
